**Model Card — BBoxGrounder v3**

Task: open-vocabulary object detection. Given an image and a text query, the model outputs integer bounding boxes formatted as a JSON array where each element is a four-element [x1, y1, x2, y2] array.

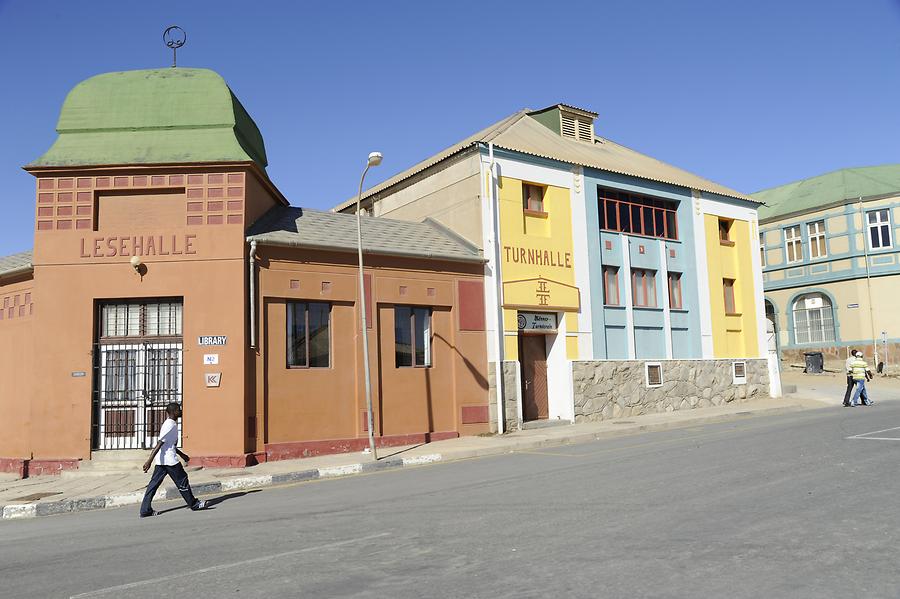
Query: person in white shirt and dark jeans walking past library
[[141, 402, 206, 518]]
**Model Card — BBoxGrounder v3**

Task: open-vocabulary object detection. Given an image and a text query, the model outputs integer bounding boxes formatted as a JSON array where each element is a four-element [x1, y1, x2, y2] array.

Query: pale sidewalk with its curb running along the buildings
[[0, 396, 824, 519]]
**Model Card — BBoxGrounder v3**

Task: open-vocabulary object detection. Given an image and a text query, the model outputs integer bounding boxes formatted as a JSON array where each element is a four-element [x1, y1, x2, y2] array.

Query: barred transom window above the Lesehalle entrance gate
[[100, 301, 182, 337]]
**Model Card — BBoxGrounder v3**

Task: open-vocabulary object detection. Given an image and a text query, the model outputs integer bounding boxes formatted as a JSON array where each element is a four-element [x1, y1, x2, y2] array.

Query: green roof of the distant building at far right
[[753, 164, 900, 220]]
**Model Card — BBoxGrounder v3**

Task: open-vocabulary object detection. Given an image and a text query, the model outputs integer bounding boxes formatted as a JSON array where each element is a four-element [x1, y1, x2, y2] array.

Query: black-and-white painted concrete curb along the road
[[0, 404, 809, 520]]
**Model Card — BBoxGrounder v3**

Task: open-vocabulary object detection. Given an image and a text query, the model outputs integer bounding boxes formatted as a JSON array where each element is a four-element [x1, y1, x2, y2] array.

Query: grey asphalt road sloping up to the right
[[0, 402, 900, 599]]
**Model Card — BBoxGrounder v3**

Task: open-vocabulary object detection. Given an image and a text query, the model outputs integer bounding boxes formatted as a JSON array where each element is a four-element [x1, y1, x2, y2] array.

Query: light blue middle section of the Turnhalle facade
[[584, 169, 705, 359]]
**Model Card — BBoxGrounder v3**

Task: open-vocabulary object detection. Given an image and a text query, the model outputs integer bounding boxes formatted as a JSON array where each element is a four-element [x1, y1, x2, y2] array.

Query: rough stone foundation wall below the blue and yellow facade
[[572, 359, 769, 422]]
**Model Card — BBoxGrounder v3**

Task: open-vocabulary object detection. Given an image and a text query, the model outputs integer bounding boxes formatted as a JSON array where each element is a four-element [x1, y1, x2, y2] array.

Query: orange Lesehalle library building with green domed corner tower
[[0, 68, 489, 475]]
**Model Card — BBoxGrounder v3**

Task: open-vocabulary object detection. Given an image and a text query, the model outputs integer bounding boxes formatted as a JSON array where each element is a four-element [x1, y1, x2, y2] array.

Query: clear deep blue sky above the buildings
[[0, 0, 900, 255]]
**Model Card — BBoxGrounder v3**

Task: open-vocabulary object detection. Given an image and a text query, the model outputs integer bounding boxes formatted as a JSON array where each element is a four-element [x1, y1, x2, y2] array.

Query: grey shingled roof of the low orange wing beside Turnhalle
[[247, 206, 484, 263]]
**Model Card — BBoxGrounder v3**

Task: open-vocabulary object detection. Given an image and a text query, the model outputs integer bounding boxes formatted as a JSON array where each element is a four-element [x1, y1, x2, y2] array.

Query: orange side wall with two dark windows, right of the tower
[[257, 247, 488, 450]]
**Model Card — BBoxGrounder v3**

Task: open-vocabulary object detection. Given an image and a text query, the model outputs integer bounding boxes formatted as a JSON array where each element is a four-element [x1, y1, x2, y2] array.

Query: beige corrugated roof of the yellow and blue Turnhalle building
[[334, 105, 759, 211]]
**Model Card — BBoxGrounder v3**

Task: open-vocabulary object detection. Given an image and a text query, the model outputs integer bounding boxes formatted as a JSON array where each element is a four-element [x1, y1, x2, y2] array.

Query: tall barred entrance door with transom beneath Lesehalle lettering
[[92, 300, 183, 449]]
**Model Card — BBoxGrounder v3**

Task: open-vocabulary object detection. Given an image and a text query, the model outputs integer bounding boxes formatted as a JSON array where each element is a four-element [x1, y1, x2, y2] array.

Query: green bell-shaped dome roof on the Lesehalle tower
[[28, 68, 267, 169]]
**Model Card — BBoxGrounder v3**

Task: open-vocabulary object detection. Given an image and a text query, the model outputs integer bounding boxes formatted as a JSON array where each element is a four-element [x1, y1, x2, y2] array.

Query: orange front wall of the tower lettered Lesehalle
[[14, 166, 282, 459]]
